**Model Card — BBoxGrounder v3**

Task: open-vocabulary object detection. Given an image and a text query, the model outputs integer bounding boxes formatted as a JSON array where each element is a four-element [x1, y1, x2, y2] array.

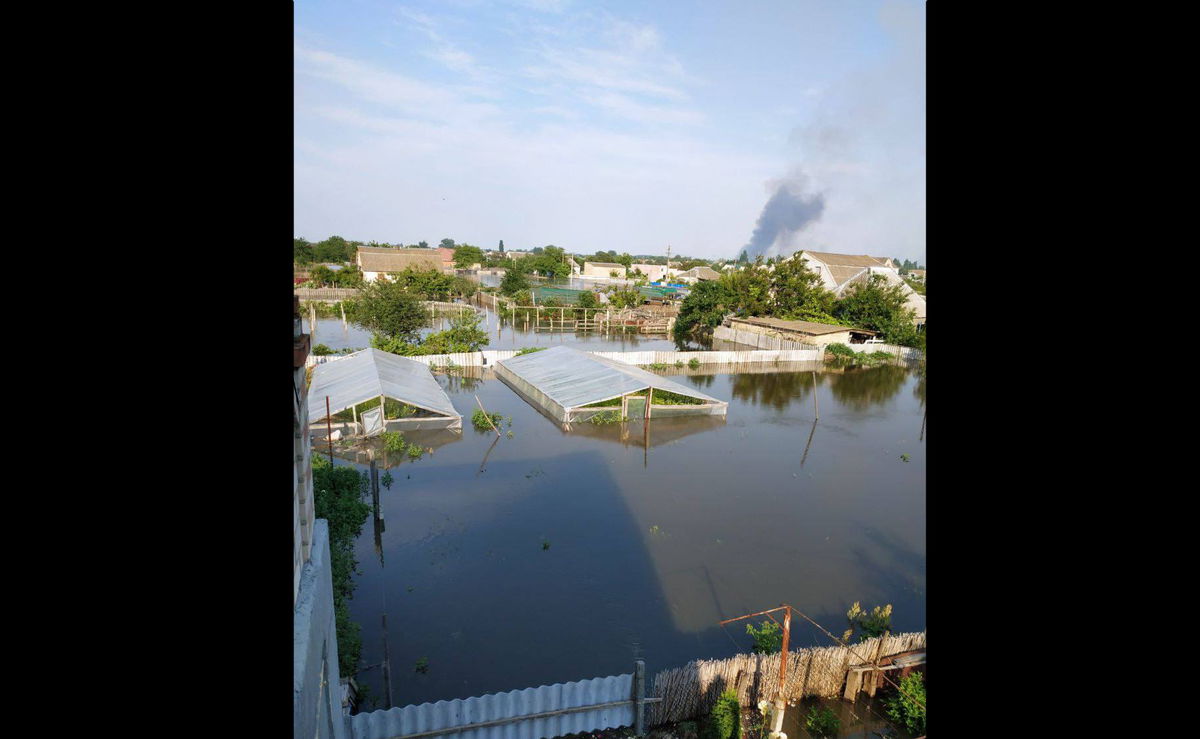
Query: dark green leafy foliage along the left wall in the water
[[312, 456, 371, 675]]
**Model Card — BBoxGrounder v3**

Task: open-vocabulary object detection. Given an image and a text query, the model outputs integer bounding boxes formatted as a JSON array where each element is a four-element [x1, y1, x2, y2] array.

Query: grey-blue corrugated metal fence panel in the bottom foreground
[[350, 674, 634, 739]]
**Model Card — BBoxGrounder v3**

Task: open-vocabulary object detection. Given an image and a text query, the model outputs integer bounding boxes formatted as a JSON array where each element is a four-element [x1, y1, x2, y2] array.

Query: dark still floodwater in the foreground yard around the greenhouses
[[331, 359, 925, 719]]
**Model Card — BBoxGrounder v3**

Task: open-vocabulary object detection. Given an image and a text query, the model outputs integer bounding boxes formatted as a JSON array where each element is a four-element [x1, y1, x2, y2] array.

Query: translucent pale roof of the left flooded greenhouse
[[308, 348, 462, 419]]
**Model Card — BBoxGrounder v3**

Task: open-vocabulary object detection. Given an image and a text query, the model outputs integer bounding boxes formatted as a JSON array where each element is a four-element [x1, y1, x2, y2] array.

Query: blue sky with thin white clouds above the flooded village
[[294, 0, 925, 262]]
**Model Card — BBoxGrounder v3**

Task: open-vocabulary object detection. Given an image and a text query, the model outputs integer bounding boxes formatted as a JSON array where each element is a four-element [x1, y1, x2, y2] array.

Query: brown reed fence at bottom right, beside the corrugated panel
[[647, 631, 925, 726]]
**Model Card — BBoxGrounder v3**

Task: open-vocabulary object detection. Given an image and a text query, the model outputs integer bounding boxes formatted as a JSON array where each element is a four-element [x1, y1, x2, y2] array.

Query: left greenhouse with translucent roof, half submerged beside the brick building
[[308, 348, 462, 435]]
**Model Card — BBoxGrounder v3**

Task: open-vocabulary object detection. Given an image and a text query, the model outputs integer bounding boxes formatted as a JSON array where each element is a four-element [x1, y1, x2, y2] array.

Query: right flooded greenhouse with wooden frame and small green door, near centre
[[496, 347, 730, 423]]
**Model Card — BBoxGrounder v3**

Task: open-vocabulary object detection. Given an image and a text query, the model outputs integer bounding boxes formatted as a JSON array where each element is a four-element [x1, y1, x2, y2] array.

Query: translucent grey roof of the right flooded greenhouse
[[497, 347, 721, 408]]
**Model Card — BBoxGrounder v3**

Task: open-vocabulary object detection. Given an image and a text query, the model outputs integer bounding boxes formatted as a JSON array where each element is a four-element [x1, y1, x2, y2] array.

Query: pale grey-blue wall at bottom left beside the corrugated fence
[[292, 519, 349, 739]]
